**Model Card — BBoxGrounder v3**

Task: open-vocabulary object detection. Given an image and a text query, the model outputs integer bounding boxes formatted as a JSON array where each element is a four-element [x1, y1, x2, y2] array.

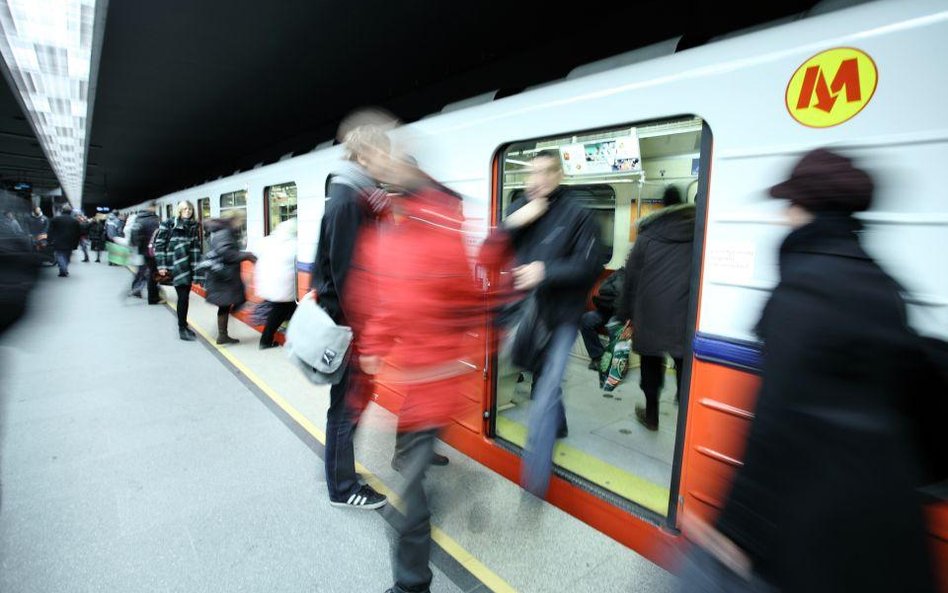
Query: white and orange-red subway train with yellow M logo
[[122, 0, 948, 591]]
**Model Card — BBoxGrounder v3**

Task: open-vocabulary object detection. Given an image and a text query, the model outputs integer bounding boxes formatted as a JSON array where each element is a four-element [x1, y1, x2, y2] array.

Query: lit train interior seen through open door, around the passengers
[[492, 117, 705, 515]]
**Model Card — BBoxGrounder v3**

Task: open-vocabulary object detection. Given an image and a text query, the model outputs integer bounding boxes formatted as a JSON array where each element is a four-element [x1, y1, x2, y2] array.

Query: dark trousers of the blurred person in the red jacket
[[392, 429, 438, 593]]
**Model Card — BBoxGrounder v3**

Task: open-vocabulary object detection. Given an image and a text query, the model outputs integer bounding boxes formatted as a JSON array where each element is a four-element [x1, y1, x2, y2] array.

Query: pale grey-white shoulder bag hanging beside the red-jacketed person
[[284, 293, 352, 385]]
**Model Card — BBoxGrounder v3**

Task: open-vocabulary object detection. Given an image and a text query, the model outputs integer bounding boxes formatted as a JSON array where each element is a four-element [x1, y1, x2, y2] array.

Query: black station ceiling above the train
[[0, 0, 817, 210]]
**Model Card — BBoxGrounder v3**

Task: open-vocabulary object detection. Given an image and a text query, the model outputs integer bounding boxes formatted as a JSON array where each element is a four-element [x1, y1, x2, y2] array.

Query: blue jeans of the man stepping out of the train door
[[520, 324, 577, 498]]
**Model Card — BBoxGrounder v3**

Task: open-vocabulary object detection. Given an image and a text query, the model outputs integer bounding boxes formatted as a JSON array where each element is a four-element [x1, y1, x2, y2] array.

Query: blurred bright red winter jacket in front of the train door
[[358, 182, 483, 431]]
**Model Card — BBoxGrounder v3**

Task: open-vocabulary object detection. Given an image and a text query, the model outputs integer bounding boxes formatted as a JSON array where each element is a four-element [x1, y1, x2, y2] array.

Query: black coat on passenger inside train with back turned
[[616, 204, 695, 358]]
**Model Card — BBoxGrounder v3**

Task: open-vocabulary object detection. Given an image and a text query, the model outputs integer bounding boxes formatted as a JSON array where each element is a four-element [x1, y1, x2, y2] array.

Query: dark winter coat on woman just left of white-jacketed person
[[198, 220, 253, 307]]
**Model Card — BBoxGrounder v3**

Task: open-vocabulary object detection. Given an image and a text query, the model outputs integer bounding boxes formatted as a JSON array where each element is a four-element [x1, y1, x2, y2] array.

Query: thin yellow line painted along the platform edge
[[165, 302, 517, 593]]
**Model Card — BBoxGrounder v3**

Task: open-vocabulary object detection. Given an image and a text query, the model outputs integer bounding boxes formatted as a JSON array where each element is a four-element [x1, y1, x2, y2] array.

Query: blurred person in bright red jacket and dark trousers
[[358, 151, 483, 593]]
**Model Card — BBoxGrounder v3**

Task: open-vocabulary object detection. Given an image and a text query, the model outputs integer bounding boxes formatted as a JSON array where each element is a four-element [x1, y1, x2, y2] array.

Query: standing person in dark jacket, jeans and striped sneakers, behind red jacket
[[311, 117, 390, 509]]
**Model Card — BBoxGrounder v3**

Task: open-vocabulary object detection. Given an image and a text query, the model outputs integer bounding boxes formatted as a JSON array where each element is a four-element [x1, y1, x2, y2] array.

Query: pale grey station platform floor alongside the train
[[0, 258, 676, 593]]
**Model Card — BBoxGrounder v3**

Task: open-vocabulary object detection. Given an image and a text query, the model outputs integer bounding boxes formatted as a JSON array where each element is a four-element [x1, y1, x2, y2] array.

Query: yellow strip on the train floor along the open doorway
[[497, 416, 670, 517]]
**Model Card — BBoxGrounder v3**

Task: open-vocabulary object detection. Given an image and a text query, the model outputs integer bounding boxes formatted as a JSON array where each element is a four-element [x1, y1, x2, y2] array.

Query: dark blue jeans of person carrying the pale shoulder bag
[[326, 361, 366, 502]]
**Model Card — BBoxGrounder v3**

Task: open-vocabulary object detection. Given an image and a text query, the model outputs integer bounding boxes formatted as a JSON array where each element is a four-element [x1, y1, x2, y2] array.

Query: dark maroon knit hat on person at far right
[[770, 148, 873, 212]]
